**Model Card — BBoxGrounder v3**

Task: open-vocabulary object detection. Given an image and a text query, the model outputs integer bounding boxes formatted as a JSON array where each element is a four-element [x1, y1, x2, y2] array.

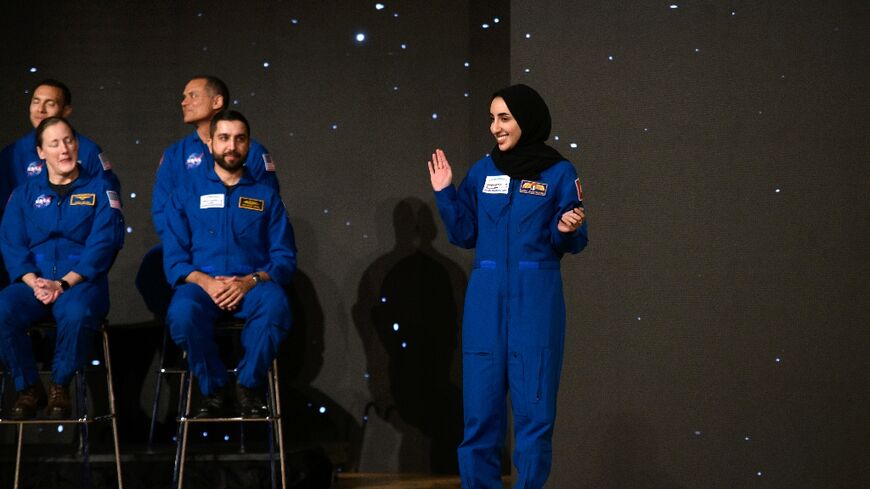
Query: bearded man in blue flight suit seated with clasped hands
[[163, 110, 296, 417]]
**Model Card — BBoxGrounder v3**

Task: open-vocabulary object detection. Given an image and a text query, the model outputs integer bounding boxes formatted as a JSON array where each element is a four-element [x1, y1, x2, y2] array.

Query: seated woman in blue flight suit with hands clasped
[[0, 117, 124, 419]]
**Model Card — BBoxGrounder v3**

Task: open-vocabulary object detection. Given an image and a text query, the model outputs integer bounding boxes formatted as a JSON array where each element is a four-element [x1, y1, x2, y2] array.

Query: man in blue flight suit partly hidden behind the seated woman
[[0, 79, 121, 287]]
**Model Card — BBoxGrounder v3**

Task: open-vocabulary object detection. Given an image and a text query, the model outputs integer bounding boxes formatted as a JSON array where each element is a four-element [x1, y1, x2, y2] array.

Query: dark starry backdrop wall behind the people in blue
[[0, 0, 870, 488]]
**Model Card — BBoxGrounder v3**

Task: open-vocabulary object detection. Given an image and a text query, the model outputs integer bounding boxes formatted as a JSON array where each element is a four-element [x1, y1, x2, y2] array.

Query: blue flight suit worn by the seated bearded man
[[163, 163, 296, 395]]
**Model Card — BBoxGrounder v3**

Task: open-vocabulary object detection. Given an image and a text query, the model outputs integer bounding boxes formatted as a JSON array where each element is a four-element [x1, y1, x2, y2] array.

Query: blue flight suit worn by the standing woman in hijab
[[435, 156, 587, 489]]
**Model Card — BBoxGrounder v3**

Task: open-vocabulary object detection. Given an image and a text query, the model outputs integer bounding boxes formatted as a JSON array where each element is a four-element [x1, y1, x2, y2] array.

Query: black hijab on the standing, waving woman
[[490, 84, 565, 180]]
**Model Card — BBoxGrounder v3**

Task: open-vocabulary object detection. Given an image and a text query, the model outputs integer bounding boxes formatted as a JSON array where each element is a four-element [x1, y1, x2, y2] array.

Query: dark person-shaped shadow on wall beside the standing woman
[[353, 198, 466, 474]]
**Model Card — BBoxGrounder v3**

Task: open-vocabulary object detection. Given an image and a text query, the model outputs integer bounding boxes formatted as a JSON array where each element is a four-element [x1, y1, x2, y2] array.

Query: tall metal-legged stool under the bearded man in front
[[161, 318, 287, 489]]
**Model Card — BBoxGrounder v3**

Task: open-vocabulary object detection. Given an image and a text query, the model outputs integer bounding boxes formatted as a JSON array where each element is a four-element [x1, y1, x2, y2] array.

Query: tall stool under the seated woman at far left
[[0, 320, 124, 489]]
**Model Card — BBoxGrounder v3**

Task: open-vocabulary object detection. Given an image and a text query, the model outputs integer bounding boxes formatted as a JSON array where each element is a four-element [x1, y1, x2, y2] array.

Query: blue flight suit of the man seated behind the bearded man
[[136, 131, 280, 317]]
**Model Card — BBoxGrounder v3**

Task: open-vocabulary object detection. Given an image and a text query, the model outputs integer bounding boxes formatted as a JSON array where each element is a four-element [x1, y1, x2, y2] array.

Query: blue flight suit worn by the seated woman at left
[[0, 166, 124, 390]]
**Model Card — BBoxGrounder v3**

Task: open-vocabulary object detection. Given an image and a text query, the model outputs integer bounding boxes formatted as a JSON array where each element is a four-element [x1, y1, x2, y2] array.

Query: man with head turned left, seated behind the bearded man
[[136, 75, 280, 318]]
